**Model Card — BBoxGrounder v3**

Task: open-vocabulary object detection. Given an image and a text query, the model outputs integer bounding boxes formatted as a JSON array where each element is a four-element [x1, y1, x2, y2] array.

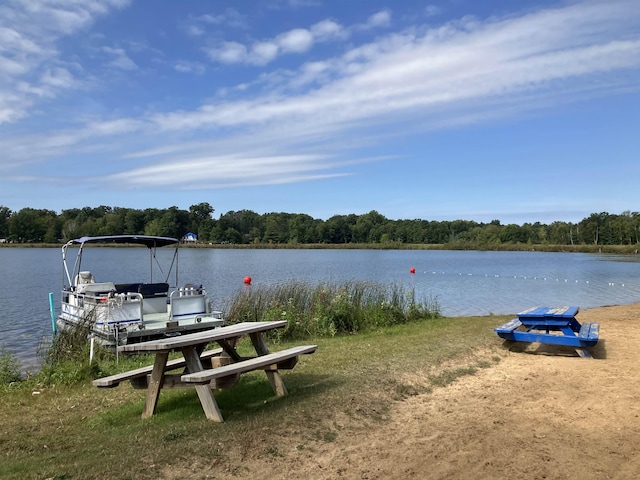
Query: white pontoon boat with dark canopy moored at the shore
[[56, 235, 224, 346]]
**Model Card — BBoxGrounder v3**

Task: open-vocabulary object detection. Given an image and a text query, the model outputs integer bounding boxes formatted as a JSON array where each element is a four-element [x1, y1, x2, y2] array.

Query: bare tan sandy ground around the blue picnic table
[[165, 304, 640, 480]]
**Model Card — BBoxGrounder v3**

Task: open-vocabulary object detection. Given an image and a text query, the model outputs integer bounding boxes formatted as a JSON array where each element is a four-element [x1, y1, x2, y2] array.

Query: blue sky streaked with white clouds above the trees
[[0, 0, 640, 224]]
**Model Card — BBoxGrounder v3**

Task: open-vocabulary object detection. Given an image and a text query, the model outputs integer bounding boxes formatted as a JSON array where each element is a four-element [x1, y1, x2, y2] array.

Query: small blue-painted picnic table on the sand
[[494, 306, 600, 357]]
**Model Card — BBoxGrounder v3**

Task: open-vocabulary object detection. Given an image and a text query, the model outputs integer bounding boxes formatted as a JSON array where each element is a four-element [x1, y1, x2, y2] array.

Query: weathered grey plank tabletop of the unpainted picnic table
[[118, 320, 287, 353]]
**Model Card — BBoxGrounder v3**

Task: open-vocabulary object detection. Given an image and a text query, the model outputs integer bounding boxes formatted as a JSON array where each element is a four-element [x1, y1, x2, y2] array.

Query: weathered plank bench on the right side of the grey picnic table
[[181, 345, 318, 384]]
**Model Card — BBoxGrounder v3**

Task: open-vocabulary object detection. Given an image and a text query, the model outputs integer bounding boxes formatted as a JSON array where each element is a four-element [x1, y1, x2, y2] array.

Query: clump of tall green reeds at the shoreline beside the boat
[[226, 281, 440, 339]]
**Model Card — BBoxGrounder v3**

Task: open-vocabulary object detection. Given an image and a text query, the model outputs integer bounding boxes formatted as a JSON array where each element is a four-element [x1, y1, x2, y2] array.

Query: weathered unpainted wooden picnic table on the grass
[[93, 321, 317, 422]]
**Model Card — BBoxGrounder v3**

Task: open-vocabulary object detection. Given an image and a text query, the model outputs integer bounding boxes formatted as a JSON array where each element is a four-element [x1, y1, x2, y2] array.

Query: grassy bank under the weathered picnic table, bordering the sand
[[0, 310, 505, 479]]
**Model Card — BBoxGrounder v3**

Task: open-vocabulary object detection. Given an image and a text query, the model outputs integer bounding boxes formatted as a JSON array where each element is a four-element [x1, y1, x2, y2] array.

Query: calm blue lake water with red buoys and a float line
[[0, 248, 640, 368]]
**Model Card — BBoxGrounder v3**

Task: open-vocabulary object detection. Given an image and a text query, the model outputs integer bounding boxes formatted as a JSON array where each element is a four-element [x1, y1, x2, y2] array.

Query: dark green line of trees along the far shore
[[0, 202, 640, 248]]
